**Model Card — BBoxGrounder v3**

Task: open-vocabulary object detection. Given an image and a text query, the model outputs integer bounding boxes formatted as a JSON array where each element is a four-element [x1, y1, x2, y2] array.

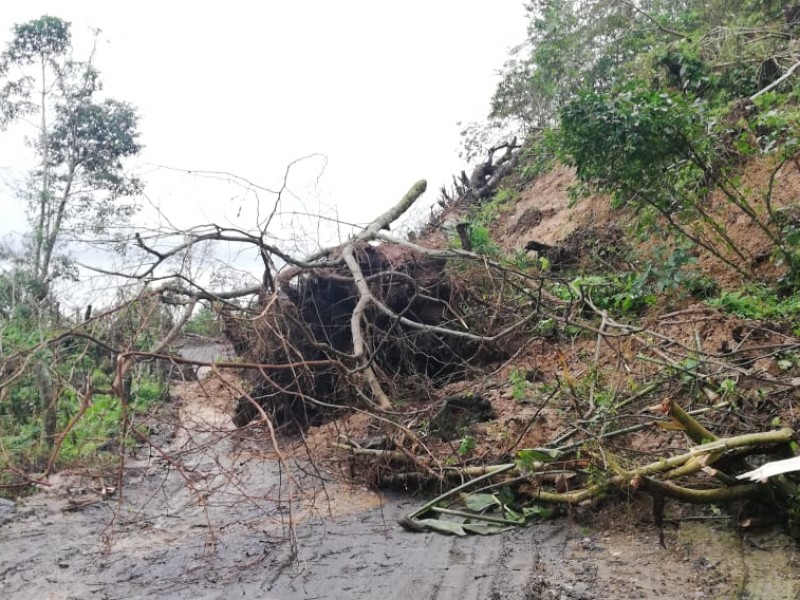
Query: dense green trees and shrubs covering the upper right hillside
[[456, 0, 800, 317]]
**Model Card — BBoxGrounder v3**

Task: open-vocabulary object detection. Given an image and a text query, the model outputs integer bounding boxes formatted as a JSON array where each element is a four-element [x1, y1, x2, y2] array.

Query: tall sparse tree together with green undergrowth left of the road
[[0, 16, 164, 482]]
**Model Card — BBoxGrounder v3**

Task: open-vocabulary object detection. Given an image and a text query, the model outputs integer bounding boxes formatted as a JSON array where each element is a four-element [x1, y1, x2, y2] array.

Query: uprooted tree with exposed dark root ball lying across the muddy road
[[120, 181, 542, 428]]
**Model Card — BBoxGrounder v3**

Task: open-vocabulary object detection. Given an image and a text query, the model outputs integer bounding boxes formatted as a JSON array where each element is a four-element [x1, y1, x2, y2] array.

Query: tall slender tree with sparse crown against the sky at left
[[0, 16, 141, 297]]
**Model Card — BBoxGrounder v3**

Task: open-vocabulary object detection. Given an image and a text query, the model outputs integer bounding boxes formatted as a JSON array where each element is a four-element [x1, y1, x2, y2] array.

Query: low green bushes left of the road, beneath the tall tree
[[0, 284, 172, 476]]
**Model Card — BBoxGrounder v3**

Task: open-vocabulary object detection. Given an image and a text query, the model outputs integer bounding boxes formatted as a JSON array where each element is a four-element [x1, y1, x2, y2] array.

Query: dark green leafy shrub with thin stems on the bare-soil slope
[[561, 82, 800, 279]]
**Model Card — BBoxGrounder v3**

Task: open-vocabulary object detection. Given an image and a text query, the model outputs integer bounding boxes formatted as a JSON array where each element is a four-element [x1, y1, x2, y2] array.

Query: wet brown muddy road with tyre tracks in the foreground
[[0, 381, 800, 600]]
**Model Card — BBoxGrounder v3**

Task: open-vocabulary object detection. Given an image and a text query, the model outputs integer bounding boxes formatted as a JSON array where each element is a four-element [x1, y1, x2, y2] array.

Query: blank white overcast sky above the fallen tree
[[0, 0, 526, 298]]
